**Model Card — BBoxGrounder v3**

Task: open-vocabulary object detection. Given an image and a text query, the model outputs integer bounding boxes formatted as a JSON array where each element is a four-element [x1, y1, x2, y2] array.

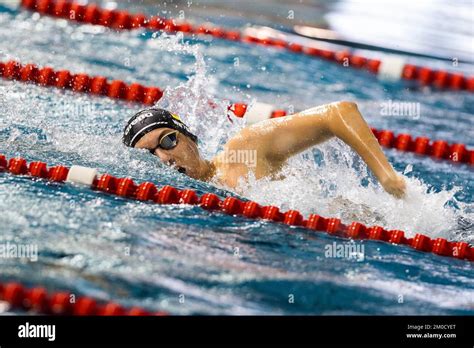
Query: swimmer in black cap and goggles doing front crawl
[[123, 101, 406, 198]]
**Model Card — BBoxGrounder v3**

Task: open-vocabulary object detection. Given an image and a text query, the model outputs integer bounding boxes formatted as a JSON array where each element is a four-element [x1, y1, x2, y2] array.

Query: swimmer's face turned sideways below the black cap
[[135, 128, 202, 178]]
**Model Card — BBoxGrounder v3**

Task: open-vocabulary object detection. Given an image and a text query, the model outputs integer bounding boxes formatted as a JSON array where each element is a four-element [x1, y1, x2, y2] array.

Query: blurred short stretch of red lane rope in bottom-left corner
[[0, 282, 169, 316]]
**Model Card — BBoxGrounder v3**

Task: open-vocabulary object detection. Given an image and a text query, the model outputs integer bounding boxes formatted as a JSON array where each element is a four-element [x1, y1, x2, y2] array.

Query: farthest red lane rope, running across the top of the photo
[[16, 0, 474, 92]]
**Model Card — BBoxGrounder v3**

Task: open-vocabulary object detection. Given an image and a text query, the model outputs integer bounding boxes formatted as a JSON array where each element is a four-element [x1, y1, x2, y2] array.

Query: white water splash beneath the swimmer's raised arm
[[239, 141, 472, 240]]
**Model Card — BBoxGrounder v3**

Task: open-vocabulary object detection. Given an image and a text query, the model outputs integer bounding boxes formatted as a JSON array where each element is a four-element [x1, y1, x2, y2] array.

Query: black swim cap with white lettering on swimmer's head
[[122, 108, 197, 147]]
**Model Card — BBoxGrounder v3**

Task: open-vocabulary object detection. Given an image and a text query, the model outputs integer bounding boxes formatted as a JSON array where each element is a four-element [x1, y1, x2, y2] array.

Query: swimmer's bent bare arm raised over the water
[[241, 101, 405, 198]]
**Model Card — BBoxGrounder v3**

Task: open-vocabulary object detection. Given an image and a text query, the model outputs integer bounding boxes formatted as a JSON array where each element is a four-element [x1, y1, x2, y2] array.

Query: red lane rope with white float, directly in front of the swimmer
[[0, 155, 474, 261]]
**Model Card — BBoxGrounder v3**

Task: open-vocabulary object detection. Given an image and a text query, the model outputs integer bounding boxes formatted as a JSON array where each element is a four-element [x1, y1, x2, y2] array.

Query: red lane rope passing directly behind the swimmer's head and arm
[[0, 61, 474, 165]]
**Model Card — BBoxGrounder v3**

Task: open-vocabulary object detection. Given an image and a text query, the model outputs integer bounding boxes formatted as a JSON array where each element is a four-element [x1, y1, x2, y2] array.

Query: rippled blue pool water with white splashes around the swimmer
[[0, 0, 474, 315]]
